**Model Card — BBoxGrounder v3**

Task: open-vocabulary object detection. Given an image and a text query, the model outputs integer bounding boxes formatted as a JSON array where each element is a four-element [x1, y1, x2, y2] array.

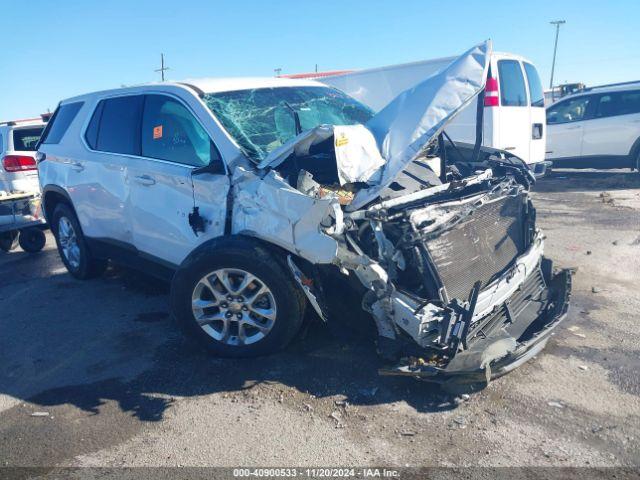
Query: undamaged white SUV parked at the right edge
[[546, 82, 640, 170]]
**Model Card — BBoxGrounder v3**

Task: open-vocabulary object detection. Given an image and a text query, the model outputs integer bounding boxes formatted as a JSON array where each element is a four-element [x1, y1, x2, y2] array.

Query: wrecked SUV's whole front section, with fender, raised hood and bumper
[[232, 44, 571, 383]]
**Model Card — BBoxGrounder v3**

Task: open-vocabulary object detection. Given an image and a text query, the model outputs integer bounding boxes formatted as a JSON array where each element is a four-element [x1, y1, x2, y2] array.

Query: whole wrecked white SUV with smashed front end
[[38, 43, 570, 382]]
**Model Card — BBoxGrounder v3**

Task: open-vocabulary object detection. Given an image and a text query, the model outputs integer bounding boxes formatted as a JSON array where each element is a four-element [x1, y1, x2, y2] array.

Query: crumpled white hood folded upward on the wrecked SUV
[[258, 40, 491, 210]]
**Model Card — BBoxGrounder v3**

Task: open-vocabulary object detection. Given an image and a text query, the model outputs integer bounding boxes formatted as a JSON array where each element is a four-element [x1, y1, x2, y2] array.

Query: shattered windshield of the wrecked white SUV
[[204, 87, 373, 161]]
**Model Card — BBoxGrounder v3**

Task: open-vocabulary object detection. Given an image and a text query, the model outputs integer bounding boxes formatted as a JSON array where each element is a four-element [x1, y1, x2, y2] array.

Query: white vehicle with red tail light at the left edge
[[0, 119, 45, 194]]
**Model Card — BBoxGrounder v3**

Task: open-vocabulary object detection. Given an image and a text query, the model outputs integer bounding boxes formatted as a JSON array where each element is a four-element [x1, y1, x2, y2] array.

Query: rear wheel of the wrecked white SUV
[[51, 203, 107, 280]]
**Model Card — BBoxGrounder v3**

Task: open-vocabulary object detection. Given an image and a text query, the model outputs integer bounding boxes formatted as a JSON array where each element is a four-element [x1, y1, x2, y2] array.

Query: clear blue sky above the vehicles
[[0, 0, 640, 120]]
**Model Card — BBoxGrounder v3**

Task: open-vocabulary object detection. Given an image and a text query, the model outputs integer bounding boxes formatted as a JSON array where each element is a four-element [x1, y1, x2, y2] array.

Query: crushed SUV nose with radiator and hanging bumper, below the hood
[[338, 170, 571, 383]]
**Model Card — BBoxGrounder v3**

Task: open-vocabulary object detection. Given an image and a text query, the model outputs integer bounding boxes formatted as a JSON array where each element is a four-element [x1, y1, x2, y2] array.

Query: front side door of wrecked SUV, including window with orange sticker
[[127, 94, 229, 267]]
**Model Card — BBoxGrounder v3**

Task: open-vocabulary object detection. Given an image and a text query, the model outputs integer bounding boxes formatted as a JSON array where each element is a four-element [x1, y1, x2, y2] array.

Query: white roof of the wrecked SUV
[[61, 77, 327, 104]]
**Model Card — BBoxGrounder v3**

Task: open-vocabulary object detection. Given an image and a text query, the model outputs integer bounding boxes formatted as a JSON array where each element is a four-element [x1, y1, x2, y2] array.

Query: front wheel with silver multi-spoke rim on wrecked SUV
[[171, 238, 304, 357]]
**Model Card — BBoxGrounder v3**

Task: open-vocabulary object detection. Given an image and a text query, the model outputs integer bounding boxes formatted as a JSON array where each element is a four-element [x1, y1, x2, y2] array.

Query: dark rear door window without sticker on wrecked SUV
[[95, 95, 144, 155]]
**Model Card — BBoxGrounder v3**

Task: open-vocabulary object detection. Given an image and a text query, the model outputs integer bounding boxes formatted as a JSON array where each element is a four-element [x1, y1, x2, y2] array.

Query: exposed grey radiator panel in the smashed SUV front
[[425, 193, 526, 300]]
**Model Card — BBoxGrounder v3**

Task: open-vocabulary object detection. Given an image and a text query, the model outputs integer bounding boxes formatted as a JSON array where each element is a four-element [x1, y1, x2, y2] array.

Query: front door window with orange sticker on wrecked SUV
[[141, 95, 220, 167]]
